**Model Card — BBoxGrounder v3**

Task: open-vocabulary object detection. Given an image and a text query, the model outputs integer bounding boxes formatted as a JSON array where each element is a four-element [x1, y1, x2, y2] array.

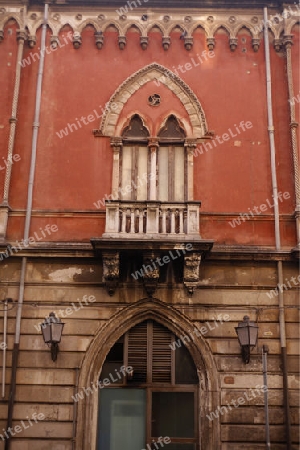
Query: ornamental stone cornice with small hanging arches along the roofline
[[0, 2, 300, 51]]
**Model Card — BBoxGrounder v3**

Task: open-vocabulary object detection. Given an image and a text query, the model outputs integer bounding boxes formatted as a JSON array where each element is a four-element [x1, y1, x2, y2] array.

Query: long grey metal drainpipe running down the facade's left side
[[5, 3, 48, 450]]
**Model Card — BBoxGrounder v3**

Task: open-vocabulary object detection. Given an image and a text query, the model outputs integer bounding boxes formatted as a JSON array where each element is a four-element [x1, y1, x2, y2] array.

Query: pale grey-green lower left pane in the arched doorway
[[97, 389, 146, 450]]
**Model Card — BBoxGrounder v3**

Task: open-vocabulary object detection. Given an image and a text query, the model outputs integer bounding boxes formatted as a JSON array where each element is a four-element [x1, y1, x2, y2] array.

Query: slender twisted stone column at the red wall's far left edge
[[1, 11, 26, 232]]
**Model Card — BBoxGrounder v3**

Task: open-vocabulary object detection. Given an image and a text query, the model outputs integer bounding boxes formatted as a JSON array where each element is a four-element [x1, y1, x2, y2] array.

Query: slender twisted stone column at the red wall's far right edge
[[283, 35, 300, 250]]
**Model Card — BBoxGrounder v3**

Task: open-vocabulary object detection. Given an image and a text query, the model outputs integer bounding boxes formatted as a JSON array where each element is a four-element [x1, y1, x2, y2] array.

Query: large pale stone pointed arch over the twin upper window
[[99, 63, 208, 138]]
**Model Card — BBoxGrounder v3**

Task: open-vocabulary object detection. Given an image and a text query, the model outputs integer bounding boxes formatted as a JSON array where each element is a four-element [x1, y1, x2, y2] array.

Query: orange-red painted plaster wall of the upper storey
[[0, 22, 299, 246]]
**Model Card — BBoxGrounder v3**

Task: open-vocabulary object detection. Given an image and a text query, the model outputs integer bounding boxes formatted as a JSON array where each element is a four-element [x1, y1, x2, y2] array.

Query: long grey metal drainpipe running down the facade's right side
[[264, 8, 292, 450]]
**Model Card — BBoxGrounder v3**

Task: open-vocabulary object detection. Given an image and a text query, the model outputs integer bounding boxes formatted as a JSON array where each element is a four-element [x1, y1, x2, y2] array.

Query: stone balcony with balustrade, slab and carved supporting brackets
[[91, 200, 213, 297]]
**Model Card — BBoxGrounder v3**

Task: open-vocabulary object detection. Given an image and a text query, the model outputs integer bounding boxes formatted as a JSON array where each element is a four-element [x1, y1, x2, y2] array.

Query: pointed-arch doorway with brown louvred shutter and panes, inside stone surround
[[97, 320, 199, 450]]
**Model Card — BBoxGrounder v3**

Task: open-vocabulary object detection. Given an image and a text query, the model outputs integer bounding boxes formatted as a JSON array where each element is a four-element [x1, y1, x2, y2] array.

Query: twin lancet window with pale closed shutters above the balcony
[[118, 115, 187, 202]]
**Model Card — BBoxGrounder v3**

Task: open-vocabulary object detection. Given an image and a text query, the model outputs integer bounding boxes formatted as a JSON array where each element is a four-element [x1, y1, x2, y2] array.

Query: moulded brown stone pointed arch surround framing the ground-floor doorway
[[76, 298, 220, 450]]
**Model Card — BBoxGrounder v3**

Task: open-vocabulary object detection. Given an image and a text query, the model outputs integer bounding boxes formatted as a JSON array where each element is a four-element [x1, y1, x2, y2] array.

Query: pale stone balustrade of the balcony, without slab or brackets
[[103, 200, 201, 241]]
